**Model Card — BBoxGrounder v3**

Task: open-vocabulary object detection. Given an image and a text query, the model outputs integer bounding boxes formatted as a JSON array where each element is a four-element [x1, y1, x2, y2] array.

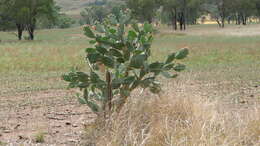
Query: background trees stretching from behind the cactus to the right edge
[[80, 0, 260, 30]]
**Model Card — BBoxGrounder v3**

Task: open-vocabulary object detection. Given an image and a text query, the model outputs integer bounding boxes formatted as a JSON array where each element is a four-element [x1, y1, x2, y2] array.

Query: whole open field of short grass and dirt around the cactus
[[0, 25, 260, 145]]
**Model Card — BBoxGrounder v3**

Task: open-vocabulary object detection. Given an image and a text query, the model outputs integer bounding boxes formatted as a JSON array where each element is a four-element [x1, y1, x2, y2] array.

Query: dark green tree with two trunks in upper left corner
[[1, 0, 57, 40]]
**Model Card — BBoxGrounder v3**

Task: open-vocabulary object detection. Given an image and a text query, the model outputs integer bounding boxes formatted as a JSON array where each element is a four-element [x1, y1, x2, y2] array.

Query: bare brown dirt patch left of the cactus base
[[0, 90, 94, 145]]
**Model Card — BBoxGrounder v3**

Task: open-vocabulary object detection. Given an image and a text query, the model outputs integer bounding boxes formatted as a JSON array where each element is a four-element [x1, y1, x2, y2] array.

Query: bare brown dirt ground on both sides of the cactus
[[0, 77, 260, 145]]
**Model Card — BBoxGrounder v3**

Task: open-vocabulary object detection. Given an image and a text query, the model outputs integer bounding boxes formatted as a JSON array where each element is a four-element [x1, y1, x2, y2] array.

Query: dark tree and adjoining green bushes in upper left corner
[[0, 0, 73, 40]]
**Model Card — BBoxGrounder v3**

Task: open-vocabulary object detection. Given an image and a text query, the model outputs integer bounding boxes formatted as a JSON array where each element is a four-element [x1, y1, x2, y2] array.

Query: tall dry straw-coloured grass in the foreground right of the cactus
[[83, 93, 260, 146]]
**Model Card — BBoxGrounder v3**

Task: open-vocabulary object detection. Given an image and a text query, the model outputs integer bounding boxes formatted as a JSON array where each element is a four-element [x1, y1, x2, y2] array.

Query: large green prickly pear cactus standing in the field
[[63, 13, 188, 117]]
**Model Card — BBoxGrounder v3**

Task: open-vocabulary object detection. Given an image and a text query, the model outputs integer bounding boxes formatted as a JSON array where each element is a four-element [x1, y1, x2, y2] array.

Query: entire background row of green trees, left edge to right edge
[[0, 0, 260, 40]]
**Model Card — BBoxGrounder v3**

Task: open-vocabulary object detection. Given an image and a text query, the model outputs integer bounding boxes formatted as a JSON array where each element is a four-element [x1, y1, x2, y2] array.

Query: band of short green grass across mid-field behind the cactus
[[0, 25, 260, 95]]
